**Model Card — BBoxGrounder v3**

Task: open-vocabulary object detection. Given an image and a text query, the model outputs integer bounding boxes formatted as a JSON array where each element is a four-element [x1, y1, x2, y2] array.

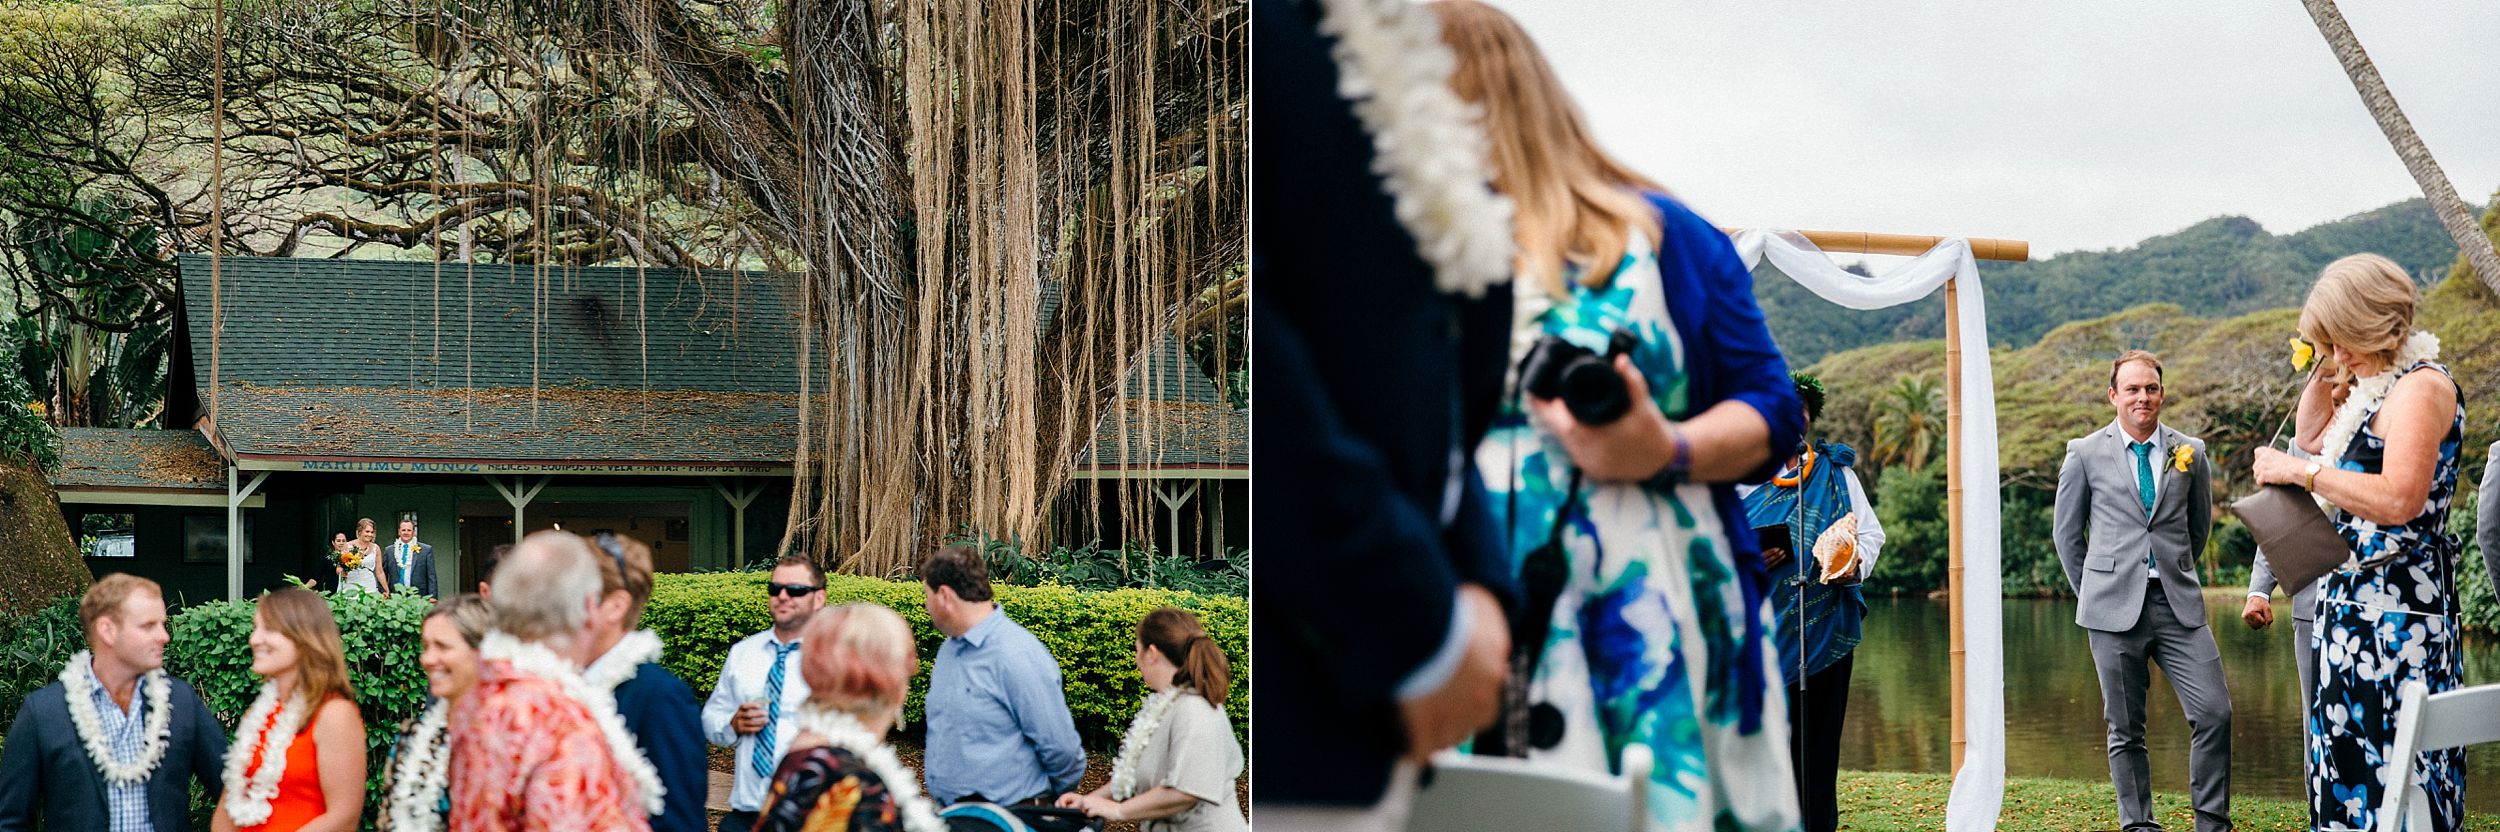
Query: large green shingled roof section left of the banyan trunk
[[183, 255, 800, 465]]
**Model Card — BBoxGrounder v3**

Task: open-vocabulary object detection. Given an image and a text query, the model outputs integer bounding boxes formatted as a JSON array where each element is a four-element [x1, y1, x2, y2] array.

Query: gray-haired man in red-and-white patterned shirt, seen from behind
[[450, 530, 660, 832]]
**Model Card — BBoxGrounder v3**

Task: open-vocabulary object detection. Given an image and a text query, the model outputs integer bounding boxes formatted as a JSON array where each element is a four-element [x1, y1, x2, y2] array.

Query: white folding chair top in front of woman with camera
[[1408, 745, 1655, 832]]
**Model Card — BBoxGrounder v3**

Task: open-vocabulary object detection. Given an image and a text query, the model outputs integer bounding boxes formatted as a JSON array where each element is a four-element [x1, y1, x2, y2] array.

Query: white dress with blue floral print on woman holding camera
[[1475, 235, 1800, 832]]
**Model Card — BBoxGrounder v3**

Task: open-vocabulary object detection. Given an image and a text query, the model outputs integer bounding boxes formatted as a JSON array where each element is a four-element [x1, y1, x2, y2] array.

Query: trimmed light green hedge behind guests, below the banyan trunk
[[643, 572, 1250, 752]]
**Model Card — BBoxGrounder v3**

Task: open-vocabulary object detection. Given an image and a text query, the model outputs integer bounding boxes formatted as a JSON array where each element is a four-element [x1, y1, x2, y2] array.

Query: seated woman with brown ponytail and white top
[[1058, 607, 1250, 832]]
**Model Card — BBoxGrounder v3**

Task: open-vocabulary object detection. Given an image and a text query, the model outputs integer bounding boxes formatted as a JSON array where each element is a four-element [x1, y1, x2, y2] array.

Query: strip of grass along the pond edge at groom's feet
[[1840, 772, 2500, 832]]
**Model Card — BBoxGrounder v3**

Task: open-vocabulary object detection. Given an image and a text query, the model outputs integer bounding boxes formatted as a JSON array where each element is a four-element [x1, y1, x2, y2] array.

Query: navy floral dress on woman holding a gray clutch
[[2308, 362, 2465, 832]]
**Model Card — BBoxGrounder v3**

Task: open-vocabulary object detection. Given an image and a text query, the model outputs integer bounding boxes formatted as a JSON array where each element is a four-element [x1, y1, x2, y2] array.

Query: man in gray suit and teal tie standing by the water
[[2055, 350, 2230, 832]]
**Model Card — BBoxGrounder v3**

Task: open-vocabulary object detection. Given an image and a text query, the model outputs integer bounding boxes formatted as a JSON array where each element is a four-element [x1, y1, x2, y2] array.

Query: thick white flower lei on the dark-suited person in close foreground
[[1320, 0, 1513, 297]]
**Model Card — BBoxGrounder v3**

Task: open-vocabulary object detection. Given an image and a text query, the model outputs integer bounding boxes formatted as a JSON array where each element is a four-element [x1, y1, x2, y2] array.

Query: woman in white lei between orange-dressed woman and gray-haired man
[[378, 595, 495, 832]]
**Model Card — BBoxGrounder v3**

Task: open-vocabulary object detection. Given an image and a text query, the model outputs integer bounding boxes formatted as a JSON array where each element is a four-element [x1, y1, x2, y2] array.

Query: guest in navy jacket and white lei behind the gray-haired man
[[583, 532, 710, 832]]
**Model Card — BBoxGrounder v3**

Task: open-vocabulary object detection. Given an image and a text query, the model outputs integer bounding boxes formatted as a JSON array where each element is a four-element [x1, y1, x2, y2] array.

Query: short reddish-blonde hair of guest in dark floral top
[[800, 602, 920, 720]]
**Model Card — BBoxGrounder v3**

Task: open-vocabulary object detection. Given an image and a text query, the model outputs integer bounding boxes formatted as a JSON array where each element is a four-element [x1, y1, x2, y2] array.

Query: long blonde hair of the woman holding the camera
[[1430, 0, 1665, 295]]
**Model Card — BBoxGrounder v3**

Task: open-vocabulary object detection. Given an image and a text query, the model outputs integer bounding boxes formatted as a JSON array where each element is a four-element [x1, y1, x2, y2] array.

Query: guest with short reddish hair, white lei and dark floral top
[[755, 602, 943, 832]]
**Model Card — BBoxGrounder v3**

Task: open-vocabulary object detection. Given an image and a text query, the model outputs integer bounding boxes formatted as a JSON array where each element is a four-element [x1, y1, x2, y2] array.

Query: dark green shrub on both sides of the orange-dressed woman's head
[[165, 582, 433, 820]]
